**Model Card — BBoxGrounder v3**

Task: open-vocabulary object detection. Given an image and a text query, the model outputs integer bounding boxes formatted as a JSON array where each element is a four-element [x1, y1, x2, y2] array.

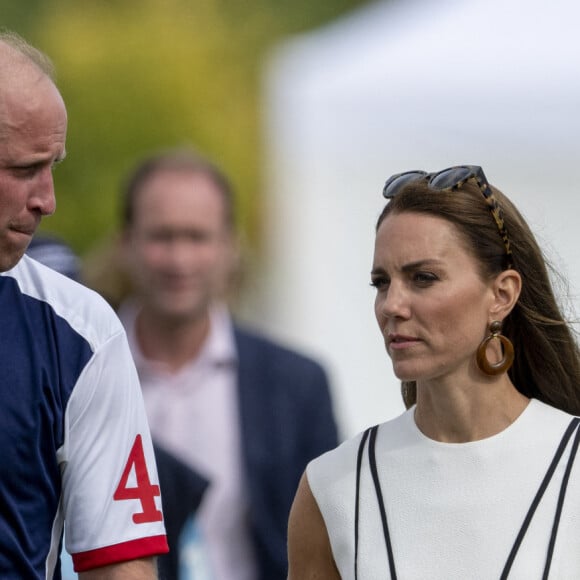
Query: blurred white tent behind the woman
[[253, 0, 580, 436]]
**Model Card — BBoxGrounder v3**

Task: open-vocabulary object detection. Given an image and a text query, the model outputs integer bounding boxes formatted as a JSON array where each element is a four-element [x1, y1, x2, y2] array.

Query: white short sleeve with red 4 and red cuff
[[59, 332, 167, 571]]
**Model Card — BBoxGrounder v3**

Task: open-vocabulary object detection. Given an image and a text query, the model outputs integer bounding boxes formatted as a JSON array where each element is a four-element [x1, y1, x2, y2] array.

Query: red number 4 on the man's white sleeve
[[113, 435, 163, 524]]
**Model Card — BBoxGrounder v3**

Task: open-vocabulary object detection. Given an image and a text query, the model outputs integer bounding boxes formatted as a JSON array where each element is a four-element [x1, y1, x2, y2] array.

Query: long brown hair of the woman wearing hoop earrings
[[376, 180, 580, 415]]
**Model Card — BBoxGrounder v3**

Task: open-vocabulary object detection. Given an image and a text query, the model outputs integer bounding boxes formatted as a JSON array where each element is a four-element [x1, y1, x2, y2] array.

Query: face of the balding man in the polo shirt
[[0, 72, 67, 271]]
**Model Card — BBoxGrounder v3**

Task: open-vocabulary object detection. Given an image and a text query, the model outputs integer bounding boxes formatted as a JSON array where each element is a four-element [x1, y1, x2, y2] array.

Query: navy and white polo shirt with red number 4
[[0, 256, 167, 580]]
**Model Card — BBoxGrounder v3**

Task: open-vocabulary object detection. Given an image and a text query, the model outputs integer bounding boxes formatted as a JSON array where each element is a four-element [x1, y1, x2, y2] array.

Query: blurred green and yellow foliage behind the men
[[0, 0, 365, 254]]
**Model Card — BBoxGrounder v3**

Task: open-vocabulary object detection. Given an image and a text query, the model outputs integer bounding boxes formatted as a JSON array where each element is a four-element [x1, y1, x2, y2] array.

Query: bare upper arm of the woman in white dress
[[288, 474, 340, 580]]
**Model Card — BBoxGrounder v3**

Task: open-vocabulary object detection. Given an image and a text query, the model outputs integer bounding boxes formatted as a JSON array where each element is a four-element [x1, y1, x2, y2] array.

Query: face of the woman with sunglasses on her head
[[371, 213, 494, 382]]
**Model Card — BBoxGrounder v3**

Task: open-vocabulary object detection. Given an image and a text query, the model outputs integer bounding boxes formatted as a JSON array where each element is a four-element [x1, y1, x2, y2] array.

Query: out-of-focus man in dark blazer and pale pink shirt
[[119, 150, 337, 580]]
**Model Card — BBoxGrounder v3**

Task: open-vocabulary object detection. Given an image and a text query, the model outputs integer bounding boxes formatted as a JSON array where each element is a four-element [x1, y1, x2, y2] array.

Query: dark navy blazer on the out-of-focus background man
[[153, 326, 338, 580]]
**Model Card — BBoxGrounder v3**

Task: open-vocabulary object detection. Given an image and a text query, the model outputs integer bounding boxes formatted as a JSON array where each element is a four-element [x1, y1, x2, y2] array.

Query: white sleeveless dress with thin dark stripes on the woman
[[307, 400, 580, 580]]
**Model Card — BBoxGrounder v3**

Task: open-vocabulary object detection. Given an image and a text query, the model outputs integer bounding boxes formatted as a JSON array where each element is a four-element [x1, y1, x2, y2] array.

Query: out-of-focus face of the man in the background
[[125, 170, 233, 321]]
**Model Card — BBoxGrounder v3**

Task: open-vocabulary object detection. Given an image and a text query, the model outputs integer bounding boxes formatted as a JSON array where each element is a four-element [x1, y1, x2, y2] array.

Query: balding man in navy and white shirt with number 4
[[0, 32, 167, 580]]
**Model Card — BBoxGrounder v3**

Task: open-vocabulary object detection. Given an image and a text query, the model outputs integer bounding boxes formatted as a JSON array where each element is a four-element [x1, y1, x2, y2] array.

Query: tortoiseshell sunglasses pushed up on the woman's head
[[383, 165, 512, 268]]
